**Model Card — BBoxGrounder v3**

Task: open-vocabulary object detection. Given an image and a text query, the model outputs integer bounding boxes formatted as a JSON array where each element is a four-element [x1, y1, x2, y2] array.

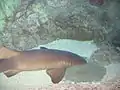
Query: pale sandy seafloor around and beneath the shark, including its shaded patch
[[0, 39, 120, 90]]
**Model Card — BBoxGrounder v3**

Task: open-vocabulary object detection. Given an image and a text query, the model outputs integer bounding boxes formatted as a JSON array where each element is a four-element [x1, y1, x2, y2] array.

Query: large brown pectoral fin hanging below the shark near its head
[[46, 68, 66, 83]]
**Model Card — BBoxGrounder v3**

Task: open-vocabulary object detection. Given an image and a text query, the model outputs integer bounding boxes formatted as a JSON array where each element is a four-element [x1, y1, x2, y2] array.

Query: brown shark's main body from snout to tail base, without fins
[[10, 49, 86, 71]]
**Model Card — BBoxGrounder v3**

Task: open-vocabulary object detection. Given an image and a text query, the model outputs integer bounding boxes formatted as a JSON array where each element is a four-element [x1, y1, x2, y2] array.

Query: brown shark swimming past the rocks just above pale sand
[[0, 47, 87, 84]]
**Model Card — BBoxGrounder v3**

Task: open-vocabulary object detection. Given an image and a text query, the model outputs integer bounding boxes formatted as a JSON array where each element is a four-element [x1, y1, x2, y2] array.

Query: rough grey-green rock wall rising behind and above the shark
[[0, 0, 120, 50]]
